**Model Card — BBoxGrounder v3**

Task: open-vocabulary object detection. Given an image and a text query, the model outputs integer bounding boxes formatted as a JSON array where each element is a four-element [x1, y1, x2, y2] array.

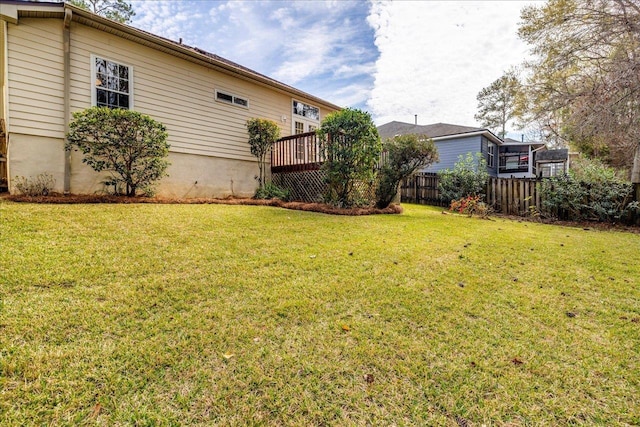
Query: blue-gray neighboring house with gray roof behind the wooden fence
[[378, 121, 546, 178]]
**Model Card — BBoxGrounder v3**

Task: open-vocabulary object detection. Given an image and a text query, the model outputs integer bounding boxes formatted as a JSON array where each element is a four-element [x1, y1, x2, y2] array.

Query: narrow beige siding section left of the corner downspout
[[7, 19, 64, 138]]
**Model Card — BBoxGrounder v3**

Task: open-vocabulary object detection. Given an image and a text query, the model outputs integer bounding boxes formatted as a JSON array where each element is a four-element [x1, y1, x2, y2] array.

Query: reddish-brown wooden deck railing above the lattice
[[271, 132, 324, 173]]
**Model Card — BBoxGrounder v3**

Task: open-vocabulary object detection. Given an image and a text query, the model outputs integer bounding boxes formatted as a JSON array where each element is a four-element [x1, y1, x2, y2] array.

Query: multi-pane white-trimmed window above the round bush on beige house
[[91, 56, 133, 110]]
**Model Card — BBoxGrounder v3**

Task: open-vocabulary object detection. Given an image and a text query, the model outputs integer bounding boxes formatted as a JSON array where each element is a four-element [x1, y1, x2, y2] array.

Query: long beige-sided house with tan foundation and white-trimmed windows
[[0, 0, 339, 197]]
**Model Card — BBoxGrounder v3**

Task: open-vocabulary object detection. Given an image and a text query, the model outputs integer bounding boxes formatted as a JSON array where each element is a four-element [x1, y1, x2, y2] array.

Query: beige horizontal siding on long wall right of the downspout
[[70, 23, 326, 164]]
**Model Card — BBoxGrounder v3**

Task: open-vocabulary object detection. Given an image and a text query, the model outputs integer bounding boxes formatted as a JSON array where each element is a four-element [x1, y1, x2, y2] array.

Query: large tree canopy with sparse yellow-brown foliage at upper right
[[519, 0, 640, 182]]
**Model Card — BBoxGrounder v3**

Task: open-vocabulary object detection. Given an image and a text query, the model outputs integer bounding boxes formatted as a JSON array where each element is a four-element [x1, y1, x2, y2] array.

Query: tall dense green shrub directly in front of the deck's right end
[[317, 108, 381, 207]]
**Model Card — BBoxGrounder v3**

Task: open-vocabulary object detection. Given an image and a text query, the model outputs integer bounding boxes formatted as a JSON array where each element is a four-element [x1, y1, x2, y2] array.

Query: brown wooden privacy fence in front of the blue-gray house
[[400, 173, 541, 215]]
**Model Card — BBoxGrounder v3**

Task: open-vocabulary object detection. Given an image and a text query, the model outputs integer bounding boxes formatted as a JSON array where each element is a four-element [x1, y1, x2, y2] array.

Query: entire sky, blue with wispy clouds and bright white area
[[131, 0, 531, 130]]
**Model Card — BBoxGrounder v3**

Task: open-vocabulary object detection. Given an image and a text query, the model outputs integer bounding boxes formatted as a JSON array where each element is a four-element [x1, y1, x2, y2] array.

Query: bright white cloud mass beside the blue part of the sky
[[367, 1, 530, 125]]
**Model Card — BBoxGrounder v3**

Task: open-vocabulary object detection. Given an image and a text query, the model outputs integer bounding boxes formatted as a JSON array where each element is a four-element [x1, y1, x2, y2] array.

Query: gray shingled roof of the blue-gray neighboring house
[[378, 121, 503, 145]]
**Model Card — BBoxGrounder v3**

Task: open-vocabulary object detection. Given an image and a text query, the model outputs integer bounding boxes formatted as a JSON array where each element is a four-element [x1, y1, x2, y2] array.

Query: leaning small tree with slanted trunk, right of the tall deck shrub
[[376, 135, 438, 209]]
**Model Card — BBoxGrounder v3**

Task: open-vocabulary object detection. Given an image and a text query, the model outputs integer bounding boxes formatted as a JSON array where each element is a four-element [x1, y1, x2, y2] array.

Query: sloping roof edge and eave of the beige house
[[0, 0, 341, 110]]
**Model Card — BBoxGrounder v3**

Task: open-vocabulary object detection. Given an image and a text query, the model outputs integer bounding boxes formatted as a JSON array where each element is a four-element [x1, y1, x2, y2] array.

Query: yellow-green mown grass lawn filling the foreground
[[0, 201, 640, 426]]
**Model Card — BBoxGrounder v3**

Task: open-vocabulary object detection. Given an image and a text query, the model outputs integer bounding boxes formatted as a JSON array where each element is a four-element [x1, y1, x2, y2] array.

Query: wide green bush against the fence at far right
[[540, 160, 637, 222]]
